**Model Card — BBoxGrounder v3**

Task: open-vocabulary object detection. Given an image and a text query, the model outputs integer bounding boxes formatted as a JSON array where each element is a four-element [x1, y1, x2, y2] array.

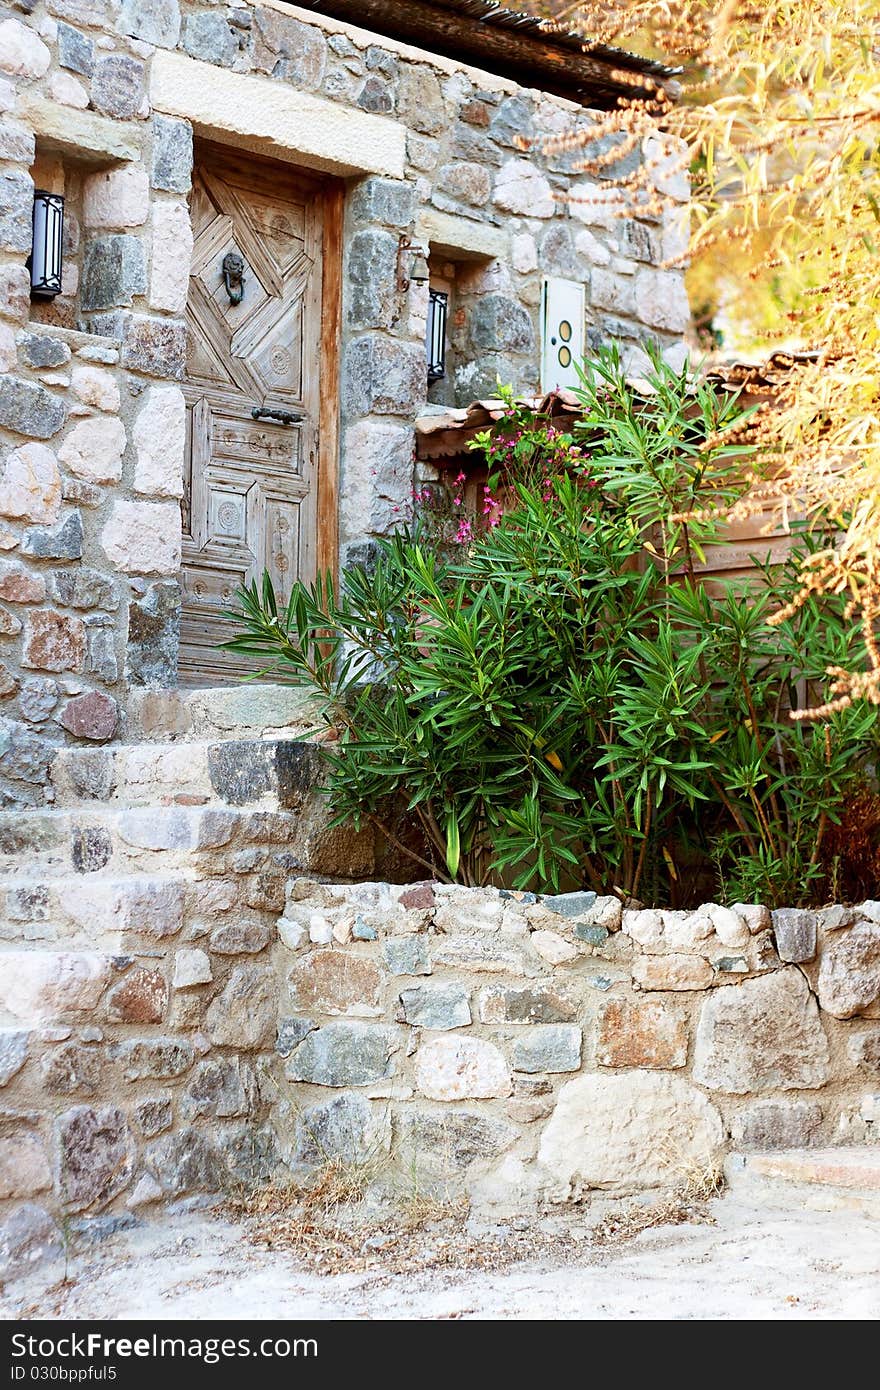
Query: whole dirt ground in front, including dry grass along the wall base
[[0, 1195, 880, 1321]]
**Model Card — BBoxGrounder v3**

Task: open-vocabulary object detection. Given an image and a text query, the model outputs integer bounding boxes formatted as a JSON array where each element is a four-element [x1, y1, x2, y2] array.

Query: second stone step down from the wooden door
[[51, 738, 323, 809]]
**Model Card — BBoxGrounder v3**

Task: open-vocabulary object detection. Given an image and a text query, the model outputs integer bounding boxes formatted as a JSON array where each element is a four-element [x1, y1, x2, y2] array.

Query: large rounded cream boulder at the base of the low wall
[[538, 1070, 723, 1197]]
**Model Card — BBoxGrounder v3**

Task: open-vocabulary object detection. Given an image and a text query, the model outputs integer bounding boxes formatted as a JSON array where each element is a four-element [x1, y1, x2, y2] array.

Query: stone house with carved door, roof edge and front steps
[[0, 0, 706, 1262]]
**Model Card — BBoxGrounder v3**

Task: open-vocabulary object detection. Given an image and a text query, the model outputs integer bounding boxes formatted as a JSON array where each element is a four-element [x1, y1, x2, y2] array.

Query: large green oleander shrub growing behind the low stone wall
[[227, 344, 877, 902]]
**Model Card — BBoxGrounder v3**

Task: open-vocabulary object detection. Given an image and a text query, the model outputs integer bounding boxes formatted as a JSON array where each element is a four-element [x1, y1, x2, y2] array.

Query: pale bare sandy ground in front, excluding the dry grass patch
[[0, 1197, 880, 1321]]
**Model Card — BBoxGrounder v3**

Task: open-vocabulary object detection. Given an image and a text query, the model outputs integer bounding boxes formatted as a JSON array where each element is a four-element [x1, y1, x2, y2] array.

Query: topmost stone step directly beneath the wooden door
[[128, 681, 320, 744]]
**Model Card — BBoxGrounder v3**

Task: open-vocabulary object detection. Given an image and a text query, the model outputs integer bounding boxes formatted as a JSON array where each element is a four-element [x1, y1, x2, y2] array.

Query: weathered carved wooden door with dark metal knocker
[[181, 152, 323, 685]]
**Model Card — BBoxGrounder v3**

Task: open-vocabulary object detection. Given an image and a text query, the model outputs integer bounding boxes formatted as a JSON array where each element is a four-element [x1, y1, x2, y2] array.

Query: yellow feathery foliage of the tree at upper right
[[539, 0, 880, 716]]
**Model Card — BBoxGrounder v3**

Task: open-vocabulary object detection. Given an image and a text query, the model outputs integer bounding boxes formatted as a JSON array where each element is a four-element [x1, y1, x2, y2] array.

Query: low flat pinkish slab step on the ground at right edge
[[724, 1144, 880, 1218]]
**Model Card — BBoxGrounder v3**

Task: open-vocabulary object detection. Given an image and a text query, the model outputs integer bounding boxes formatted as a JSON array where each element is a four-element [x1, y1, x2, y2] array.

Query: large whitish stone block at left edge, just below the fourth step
[[0, 951, 110, 1023]]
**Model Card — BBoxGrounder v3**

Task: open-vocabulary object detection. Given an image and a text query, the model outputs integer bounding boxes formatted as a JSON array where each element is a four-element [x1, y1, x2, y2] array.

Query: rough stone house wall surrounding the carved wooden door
[[0, 0, 687, 808]]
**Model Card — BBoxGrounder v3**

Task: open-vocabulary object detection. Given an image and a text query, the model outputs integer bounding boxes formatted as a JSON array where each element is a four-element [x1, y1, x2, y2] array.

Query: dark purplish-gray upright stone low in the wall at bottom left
[[56, 1105, 138, 1211]]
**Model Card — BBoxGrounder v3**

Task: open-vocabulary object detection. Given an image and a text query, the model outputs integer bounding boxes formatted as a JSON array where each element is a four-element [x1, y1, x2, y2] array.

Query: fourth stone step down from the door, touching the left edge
[[0, 873, 193, 960]]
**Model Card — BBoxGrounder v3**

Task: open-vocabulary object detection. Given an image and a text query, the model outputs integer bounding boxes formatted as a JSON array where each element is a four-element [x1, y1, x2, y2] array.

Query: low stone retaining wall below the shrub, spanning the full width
[[0, 878, 880, 1273]]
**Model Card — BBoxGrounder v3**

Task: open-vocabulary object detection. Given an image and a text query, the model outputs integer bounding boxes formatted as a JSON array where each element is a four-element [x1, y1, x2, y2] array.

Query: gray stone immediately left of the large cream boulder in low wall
[[396, 1108, 519, 1177]]
